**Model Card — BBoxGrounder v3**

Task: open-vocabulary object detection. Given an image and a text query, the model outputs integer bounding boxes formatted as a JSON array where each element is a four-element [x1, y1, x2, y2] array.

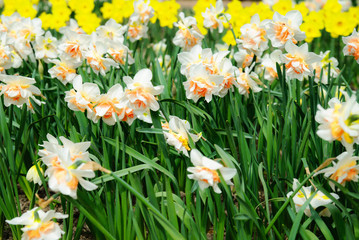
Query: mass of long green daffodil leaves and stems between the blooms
[[0, 19, 359, 240]]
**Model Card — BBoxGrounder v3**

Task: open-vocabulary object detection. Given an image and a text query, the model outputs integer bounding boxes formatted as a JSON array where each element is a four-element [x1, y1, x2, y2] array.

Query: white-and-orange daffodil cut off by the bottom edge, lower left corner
[[6, 207, 68, 240]]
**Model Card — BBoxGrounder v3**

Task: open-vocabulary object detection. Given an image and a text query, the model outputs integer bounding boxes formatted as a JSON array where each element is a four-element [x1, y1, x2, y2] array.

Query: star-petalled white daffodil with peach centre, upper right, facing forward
[[282, 41, 322, 81]]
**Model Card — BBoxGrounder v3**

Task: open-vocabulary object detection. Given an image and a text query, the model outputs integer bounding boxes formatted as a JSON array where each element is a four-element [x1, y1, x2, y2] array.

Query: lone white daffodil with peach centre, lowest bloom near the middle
[[187, 149, 237, 193]]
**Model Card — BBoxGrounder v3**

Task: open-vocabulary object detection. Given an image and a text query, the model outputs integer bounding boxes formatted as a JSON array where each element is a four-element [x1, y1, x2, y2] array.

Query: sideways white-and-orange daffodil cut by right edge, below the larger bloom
[[315, 149, 359, 190]]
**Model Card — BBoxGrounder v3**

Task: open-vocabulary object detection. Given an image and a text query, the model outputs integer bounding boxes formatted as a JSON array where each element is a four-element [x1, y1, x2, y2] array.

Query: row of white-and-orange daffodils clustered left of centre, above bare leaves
[[65, 69, 163, 125]]
